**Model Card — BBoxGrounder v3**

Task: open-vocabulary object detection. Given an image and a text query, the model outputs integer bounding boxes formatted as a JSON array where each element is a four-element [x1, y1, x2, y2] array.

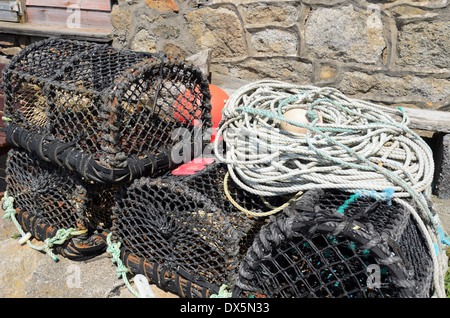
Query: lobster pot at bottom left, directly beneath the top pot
[[6, 149, 117, 260]]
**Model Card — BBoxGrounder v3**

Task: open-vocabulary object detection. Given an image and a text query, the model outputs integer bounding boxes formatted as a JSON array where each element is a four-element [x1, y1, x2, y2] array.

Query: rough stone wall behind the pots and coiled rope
[[111, 0, 450, 110]]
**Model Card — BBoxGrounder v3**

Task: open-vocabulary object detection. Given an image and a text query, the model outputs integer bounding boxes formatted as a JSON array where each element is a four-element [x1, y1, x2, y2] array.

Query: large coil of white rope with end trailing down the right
[[214, 80, 445, 296]]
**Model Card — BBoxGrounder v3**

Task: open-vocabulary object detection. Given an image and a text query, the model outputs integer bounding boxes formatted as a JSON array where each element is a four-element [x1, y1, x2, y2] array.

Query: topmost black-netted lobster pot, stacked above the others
[[3, 39, 211, 183]]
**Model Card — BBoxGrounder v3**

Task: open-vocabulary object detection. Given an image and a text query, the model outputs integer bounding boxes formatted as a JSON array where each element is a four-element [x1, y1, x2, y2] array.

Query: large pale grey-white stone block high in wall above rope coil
[[305, 5, 386, 65]]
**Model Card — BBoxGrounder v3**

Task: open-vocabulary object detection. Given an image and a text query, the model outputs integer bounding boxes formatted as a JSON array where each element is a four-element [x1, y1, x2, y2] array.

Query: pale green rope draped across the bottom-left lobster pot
[[2, 191, 86, 261]]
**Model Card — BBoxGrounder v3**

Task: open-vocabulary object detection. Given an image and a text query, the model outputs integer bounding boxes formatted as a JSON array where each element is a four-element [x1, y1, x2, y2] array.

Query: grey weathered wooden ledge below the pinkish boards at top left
[[0, 22, 112, 42]]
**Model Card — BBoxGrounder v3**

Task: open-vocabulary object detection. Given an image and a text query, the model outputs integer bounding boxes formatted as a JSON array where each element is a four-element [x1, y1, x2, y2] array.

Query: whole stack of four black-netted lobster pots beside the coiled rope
[[3, 39, 440, 298]]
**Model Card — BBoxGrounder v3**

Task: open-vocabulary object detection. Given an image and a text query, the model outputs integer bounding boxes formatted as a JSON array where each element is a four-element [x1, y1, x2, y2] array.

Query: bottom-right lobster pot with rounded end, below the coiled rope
[[236, 190, 433, 298]]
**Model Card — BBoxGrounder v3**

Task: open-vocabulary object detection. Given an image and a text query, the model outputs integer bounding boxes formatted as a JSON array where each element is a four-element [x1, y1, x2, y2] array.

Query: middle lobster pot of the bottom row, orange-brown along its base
[[112, 159, 278, 298]]
